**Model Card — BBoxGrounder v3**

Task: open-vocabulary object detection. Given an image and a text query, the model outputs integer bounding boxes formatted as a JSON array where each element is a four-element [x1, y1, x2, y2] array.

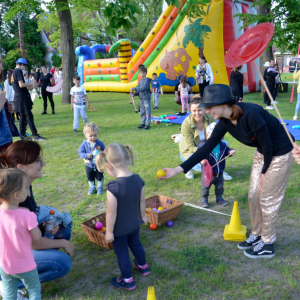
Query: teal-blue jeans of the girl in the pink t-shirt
[[0, 267, 42, 300]]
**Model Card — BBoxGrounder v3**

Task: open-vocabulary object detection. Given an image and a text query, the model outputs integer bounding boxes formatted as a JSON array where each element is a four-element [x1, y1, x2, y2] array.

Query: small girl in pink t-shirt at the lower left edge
[[0, 169, 41, 300]]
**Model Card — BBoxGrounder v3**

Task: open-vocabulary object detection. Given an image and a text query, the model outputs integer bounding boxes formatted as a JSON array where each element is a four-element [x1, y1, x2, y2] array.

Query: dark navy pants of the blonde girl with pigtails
[[112, 227, 146, 278]]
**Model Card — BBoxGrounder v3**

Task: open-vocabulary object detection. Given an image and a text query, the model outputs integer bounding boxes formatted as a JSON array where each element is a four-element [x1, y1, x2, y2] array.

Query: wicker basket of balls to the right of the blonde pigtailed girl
[[146, 195, 183, 227]]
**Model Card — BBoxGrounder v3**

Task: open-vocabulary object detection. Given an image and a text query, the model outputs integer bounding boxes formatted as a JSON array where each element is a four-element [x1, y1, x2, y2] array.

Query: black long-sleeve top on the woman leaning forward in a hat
[[180, 103, 293, 174]]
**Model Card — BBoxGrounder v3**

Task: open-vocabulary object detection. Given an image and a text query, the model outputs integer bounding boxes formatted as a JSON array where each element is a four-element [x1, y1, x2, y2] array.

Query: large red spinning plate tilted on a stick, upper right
[[225, 23, 274, 68]]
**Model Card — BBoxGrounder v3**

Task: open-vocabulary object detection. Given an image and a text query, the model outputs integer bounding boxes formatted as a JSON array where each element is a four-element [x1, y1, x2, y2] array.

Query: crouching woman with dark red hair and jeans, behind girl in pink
[[0, 140, 74, 295]]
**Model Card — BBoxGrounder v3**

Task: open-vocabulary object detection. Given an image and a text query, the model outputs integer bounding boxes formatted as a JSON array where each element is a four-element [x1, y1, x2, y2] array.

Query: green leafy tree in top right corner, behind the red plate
[[236, 0, 300, 69]]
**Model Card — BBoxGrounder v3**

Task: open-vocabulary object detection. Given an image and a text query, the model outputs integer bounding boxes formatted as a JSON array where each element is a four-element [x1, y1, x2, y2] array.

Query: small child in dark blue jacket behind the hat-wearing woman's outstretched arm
[[201, 122, 235, 208]]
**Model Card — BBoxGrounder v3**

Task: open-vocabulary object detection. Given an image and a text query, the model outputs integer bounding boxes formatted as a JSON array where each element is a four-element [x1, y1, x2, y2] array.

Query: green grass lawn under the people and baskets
[[16, 85, 300, 300]]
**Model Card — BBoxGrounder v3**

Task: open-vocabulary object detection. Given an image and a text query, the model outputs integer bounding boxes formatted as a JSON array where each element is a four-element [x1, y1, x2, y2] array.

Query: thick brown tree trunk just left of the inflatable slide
[[55, 0, 76, 103]]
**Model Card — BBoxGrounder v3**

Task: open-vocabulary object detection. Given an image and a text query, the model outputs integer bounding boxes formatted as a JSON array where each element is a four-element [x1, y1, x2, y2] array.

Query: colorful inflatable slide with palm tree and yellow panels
[[76, 0, 259, 93]]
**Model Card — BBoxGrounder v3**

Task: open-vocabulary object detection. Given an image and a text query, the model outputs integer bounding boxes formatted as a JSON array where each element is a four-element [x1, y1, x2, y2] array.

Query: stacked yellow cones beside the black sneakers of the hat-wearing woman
[[223, 201, 247, 242]]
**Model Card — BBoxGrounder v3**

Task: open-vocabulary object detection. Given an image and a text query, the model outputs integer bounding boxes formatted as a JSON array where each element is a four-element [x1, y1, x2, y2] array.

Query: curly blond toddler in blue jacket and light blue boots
[[78, 122, 105, 195]]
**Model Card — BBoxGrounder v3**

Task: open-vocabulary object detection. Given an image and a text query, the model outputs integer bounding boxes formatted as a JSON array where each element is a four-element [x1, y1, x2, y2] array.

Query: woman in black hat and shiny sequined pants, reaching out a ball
[[162, 84, 294, 258]]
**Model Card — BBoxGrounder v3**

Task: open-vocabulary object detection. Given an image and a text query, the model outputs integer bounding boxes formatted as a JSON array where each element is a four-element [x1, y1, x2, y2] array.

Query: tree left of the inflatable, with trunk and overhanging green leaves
[[0, 0, 209, 103]]
